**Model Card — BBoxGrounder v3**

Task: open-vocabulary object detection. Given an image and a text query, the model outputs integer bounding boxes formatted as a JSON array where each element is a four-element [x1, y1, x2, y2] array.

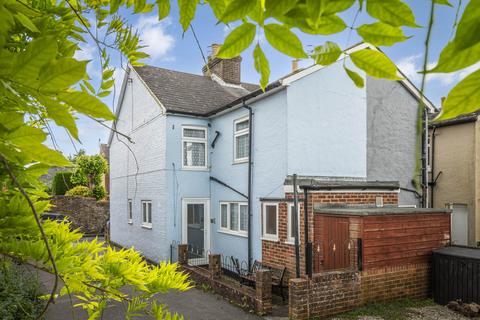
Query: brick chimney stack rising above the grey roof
[[202, 43, 242, 84]]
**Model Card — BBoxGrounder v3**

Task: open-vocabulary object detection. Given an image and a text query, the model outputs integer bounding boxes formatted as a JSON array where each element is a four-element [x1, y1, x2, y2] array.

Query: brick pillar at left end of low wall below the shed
[[288, 278, 309, 320]]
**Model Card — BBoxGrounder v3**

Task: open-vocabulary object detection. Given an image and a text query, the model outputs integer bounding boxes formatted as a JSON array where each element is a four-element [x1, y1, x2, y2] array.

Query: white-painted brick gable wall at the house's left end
[[110, 70, 170, 261]]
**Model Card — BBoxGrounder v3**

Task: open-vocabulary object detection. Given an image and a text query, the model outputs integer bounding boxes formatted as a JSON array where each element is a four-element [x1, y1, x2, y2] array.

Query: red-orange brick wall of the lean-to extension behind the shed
[[262, 192, 398, 277]]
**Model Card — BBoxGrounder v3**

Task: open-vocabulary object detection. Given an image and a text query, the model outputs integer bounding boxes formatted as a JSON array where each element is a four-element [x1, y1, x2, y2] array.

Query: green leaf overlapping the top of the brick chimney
[[217, 23, 257, 59]]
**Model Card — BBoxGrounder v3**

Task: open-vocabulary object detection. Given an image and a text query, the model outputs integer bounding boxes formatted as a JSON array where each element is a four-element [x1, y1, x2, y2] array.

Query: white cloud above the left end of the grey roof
[[135, 16, 175, 60]]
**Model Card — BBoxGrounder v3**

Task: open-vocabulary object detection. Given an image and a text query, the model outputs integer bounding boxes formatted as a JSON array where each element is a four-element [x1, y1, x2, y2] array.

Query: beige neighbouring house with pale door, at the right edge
[[429, 113, 480, 246]]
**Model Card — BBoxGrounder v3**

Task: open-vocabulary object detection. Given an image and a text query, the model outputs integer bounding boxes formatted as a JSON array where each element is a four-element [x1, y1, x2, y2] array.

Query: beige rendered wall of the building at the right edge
[[430, 122, 480, 245]]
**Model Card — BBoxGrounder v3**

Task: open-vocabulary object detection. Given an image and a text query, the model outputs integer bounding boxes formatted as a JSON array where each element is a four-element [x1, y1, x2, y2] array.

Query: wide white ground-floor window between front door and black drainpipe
[[220, 202, 248, 234]]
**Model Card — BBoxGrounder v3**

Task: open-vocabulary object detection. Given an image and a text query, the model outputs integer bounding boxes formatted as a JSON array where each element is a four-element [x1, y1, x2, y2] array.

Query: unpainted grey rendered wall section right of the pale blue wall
[[366, 77, 420, 206]]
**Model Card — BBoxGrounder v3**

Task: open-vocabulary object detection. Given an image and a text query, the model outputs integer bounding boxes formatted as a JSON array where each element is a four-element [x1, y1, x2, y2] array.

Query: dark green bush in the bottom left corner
[[0, 261, 45, 320]]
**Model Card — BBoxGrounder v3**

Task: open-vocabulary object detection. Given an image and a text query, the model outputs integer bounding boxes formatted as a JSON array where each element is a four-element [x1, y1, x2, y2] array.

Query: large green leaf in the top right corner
[[454, 0, 480, 50]]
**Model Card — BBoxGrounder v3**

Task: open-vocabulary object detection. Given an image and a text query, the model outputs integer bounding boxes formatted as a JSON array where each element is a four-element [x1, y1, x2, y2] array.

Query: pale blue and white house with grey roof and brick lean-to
[[108, 44, 436, 272]]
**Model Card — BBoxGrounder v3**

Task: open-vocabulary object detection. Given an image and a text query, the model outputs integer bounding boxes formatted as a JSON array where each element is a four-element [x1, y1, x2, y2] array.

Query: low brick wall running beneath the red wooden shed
[[289, 263, 430, 319]]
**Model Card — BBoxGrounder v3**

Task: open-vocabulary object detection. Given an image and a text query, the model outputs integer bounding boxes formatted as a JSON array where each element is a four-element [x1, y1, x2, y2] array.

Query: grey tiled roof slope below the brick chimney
[[134, 66, 259, 116]]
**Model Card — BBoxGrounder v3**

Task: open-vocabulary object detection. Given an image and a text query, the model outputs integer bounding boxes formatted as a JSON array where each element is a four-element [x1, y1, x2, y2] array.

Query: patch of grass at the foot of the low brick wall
[[333, 299, 434, 320]]
